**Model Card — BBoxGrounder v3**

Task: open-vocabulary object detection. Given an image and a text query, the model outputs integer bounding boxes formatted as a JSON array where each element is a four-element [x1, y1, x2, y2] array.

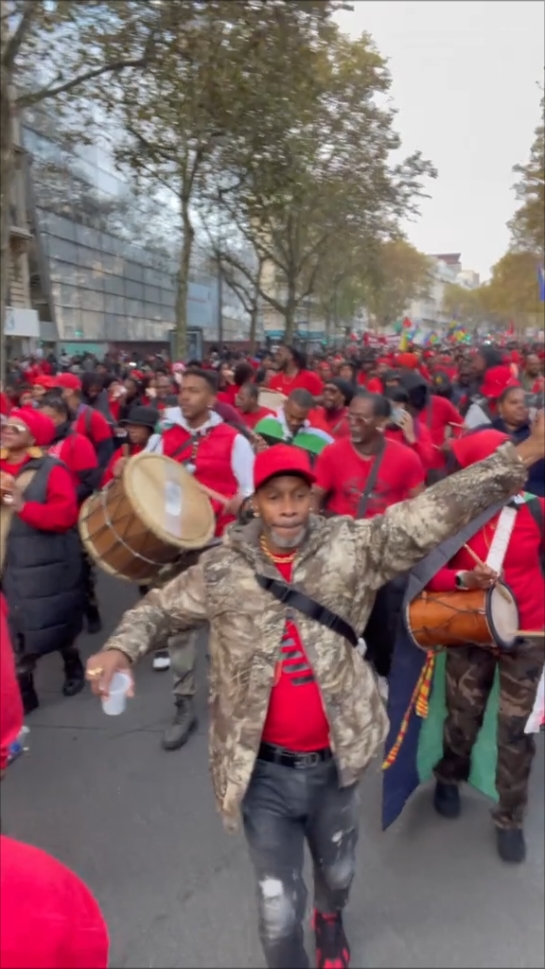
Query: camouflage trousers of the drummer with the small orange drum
[[434, 640, 545, 828]]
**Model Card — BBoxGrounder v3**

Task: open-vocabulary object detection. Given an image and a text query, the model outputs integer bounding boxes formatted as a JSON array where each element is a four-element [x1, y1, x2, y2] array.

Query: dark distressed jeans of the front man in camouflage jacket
[[243, 760, 358, 969]]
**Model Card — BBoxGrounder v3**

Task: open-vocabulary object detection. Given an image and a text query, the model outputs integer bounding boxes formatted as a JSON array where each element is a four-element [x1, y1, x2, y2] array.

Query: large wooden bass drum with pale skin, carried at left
[[79, 451, 216, 585]]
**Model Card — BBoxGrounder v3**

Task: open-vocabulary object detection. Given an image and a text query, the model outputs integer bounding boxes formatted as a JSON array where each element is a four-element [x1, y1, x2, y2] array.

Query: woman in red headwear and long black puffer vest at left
[[0, 408, 84, 713]]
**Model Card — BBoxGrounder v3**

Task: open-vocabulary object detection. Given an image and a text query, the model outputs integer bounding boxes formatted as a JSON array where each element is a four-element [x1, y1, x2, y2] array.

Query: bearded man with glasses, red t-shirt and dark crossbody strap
[[314, 391, 425, 518]]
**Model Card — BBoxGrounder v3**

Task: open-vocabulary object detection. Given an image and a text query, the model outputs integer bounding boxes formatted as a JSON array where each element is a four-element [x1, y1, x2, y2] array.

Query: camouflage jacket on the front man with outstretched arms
[[105, 443, 527, 827]]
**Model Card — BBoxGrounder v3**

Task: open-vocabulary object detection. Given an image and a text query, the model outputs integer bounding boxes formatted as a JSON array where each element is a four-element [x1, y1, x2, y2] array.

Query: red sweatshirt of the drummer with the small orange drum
[[428, 498, 545, 630]]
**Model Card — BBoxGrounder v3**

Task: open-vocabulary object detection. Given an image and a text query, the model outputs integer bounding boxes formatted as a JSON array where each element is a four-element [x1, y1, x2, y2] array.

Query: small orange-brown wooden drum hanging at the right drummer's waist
[[406, 583, 519, 651]]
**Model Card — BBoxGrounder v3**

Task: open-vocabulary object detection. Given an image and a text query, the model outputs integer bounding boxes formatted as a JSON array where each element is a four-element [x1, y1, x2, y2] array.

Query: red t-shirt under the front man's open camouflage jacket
[[262, 561, 329, 753]]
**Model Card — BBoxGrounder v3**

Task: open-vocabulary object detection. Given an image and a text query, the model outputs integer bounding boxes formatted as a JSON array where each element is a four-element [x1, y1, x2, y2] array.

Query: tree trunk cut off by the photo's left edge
[[0, 76, 14, 378]]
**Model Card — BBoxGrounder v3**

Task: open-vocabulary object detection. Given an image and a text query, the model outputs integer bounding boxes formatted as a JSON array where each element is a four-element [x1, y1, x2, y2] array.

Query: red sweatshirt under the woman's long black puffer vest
[[0, 457, 79, 532]]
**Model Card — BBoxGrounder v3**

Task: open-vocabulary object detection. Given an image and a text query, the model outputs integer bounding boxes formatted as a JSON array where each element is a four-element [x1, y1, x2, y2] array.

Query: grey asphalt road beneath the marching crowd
[[2, 579, 545, 969]]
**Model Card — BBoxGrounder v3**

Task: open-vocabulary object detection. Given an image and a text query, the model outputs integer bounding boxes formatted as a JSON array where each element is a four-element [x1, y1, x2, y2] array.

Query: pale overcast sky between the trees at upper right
[[339, 0, 545, 278]]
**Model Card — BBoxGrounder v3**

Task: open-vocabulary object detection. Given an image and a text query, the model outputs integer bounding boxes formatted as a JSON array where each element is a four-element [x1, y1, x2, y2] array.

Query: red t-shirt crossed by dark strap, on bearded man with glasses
[[315, 438, 425, 518]]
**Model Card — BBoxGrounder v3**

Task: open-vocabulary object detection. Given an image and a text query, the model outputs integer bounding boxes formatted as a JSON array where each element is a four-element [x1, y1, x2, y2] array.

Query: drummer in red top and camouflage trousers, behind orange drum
[[428, 430, 545, 862]]
